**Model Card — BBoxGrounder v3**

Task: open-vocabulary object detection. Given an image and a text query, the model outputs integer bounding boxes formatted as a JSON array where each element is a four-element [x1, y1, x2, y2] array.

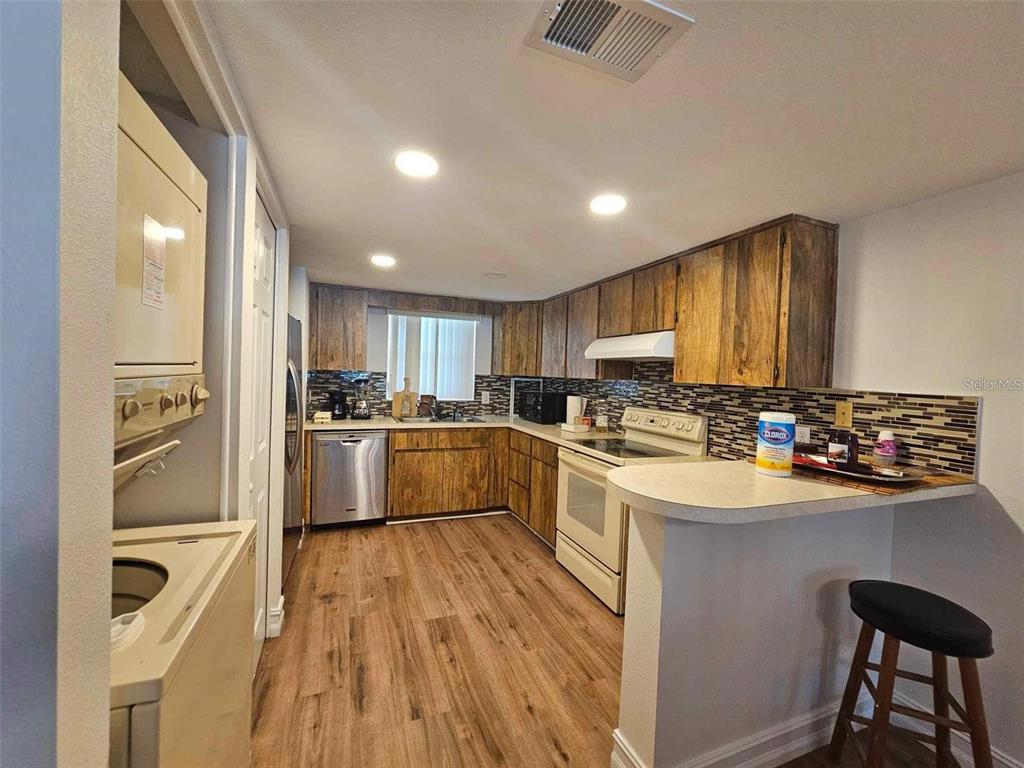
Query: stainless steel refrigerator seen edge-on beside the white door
[[281, 315, 305, 588]]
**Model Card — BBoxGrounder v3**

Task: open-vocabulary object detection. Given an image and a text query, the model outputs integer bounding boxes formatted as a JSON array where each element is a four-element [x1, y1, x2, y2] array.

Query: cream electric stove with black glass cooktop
[[555, 408, 709, 613]]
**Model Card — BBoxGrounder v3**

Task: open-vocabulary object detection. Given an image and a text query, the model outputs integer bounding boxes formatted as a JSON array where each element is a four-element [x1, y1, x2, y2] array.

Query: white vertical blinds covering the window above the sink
[[387, 313, 478, 400]]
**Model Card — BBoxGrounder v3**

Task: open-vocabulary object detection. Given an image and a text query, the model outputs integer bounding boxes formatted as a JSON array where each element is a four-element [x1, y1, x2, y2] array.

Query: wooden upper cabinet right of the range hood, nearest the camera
[[674, 219, 837, 387]]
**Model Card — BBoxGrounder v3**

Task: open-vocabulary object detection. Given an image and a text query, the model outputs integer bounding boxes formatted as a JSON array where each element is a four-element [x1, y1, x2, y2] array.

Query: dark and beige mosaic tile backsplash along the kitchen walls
[[307, 361, 981, 475]]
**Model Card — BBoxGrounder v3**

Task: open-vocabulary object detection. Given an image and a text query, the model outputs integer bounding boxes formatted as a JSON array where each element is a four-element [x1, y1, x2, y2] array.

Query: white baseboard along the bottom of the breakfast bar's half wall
[[611, 691, 872, 768]]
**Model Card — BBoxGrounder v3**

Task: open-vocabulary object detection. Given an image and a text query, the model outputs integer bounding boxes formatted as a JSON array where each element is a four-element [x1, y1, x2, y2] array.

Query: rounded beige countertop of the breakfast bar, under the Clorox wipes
[[608, 460, 977, 523]]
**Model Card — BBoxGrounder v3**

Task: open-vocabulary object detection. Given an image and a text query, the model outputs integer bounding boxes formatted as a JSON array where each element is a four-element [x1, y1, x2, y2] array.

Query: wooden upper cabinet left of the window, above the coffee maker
[[309, 285, 367, 371]]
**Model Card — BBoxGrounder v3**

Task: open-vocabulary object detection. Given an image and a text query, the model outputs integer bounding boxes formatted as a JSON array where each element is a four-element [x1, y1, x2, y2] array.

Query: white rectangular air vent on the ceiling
[[526, 0, 693, 83]]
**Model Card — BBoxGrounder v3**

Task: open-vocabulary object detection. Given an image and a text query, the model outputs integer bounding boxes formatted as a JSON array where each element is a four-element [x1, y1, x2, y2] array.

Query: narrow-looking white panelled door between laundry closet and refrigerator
[[249, 191, 276, 669]]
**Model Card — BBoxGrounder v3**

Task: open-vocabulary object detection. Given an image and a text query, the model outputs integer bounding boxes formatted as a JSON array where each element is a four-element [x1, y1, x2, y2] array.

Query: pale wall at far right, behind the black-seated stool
[[835, 173, 1024, 761]]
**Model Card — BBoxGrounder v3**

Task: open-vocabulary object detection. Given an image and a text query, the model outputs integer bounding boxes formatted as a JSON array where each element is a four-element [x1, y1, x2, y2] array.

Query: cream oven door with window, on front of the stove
[[557, 449, 626, 573]]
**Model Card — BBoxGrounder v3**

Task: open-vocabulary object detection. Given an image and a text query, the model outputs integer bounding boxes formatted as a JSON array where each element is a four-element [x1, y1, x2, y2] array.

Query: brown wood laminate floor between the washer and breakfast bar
[[252, 515, 623, 768]]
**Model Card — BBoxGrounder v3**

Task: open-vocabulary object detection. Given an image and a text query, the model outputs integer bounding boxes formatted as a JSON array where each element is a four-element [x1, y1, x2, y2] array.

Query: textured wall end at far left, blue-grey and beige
[[0, 2, 119, 766]]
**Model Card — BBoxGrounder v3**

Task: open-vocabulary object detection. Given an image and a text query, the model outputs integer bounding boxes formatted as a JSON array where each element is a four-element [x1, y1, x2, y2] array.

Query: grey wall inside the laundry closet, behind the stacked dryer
[[114, 104, 233, 528]]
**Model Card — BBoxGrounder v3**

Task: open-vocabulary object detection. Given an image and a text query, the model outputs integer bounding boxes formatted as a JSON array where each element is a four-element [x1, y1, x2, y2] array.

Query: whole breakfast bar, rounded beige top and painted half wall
[[607, 461, 976, 768]]
